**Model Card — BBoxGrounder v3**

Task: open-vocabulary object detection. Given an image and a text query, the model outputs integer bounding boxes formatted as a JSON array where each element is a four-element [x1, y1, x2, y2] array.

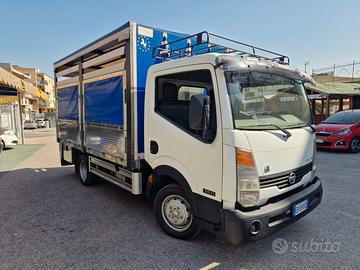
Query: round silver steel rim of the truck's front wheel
[[161, 195, 193, 232]]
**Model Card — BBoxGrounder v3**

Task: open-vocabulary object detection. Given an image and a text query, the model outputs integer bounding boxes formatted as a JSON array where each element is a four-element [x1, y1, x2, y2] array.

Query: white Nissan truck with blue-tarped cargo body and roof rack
[[54, 22, 322, 244]]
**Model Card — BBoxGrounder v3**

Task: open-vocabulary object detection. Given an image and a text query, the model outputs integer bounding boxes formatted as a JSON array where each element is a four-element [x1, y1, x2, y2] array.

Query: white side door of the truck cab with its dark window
[[145, 65, 222, 201]]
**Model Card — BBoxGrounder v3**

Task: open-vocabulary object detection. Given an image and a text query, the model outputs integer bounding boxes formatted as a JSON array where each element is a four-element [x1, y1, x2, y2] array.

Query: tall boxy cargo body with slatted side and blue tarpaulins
[[55, 22, 184, 173]]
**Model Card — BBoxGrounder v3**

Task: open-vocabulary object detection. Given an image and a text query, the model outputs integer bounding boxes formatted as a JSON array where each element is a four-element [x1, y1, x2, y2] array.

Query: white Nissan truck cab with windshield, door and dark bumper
[[145, 53, 322, 243]]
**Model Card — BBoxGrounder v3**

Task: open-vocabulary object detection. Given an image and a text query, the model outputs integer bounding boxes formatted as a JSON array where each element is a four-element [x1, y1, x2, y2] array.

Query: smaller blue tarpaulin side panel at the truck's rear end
[[58, 86, 79, 120]]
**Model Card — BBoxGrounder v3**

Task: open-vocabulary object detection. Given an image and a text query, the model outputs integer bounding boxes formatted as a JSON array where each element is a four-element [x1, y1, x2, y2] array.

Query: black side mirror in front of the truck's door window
[[189, 95, 210, 139]]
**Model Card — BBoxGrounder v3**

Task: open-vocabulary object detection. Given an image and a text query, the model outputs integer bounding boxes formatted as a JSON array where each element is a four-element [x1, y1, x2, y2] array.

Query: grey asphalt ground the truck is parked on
[[0, 131, 360, 269]]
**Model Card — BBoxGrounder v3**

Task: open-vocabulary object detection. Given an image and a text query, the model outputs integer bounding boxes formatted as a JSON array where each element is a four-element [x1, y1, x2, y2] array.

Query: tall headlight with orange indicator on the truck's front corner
[[236, 149, 260, 207]]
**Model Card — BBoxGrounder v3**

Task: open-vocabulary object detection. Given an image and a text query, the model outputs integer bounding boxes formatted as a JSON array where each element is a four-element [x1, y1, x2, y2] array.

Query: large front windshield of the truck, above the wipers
[[225, 71, 311, 130]]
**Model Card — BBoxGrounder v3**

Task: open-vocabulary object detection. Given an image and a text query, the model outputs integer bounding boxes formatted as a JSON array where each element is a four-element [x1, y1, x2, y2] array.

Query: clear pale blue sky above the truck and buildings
[[0, 0, 360, 75]]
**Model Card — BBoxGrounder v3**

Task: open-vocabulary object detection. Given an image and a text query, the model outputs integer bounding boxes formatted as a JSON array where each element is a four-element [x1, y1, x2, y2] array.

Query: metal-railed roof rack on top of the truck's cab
[[152, 31, 290, 65]]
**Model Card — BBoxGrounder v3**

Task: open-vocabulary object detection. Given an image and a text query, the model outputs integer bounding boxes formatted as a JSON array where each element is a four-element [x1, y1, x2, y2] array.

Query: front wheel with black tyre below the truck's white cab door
[[154, 184, 200, 239]]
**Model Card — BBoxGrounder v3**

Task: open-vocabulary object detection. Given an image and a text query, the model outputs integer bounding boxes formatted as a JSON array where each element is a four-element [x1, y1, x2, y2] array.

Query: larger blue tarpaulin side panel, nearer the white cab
[[84, 76, 124, 126]]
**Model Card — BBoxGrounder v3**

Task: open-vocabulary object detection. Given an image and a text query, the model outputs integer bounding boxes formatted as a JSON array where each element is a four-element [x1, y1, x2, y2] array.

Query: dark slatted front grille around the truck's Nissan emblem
[[259, 162, 313, 188]]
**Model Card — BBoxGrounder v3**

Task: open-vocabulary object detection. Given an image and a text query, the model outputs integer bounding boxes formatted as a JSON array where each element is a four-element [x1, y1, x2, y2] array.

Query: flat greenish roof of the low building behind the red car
[[305, 83, 360, 96]]
